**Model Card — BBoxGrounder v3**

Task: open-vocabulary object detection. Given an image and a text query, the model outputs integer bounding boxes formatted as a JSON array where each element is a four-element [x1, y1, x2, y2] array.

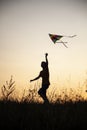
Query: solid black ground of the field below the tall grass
[[0, 101, 87, 130]]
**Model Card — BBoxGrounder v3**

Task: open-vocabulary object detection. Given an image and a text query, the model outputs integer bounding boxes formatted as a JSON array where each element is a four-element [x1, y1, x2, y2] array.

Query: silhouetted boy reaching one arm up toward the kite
[[30, 53, 50, 103]]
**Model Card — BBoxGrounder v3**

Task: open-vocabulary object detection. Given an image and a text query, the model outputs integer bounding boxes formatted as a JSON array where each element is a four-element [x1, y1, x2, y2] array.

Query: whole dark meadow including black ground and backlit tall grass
[[0, 77, 87, 130]]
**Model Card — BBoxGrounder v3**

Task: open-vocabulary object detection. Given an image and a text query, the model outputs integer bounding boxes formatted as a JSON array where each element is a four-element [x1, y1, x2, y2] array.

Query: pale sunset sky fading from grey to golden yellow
[[0, 0, 87, 94]]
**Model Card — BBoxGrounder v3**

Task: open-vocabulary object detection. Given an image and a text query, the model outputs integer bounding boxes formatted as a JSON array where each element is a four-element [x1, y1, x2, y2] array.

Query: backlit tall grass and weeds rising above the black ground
[[1, 76, 87, 103]]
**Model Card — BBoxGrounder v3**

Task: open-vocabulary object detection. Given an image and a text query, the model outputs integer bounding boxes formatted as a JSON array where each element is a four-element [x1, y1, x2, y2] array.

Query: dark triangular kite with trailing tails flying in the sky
[[49, 34, 76, 48]]
